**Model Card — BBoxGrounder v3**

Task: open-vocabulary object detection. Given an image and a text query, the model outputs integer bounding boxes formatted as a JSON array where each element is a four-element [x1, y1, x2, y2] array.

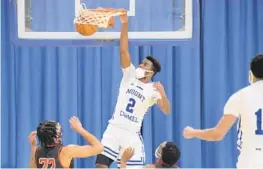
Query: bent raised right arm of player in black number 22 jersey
[[62, 117, 103, 158]]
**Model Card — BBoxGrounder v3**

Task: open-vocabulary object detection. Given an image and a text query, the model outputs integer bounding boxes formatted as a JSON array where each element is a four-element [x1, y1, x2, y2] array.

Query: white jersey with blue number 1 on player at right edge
[[224, 81, 263, 154]]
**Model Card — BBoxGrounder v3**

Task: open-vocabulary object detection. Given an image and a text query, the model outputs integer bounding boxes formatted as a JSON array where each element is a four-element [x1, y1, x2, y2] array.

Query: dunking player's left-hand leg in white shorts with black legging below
[[96, 125, 119, 168]]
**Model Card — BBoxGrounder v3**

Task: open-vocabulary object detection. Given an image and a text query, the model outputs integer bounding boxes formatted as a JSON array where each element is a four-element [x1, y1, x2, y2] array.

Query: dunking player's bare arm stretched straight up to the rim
[[120, 12, 131, 69]]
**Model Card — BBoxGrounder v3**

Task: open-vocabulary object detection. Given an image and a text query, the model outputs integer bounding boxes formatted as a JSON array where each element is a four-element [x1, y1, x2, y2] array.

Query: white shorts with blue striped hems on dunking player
[[101, 124, 145, 168]]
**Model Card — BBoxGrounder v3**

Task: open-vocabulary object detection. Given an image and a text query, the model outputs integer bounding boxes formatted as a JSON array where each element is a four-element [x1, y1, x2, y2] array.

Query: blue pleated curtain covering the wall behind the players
[[1, 0, 263, 168]]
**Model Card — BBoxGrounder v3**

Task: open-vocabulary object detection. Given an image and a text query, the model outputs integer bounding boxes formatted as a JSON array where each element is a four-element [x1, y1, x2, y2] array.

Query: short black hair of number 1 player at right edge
[[250, 54, 263, 79]]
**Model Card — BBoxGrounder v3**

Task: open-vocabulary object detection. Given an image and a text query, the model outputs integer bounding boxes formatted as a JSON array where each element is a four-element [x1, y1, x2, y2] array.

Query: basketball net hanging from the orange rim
[[74, 3, 126, 28]]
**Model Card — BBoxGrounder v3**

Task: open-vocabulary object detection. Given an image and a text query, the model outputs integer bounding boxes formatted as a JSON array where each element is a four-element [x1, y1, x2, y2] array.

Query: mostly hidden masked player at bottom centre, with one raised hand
[[120, 142, 181, 169]]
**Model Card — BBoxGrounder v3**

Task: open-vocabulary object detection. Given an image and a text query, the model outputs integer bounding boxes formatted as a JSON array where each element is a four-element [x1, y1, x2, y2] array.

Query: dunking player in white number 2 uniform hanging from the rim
[[96, 11, 170, 168]]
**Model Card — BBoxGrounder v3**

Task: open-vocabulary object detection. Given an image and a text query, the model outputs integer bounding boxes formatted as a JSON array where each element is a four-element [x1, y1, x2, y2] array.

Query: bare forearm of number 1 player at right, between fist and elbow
[[193, 128, 223, 141]]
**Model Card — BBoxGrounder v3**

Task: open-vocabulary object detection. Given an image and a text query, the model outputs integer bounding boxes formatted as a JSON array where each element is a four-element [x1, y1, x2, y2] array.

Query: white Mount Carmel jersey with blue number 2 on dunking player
[[109, 64, 161, 132]]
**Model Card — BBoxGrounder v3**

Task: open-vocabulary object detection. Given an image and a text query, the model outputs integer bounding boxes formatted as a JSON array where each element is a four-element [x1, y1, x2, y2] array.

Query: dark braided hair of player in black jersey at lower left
[[37, 120, 62, 148]]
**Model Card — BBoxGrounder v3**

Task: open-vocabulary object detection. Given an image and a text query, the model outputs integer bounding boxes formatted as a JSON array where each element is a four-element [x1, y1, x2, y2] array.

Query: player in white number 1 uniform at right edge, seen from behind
[[183, 55, 263, 168]]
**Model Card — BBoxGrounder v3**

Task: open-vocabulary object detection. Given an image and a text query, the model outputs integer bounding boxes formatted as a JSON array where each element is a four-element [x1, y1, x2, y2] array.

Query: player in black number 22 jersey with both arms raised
[[29, 117, 103, 168]]
